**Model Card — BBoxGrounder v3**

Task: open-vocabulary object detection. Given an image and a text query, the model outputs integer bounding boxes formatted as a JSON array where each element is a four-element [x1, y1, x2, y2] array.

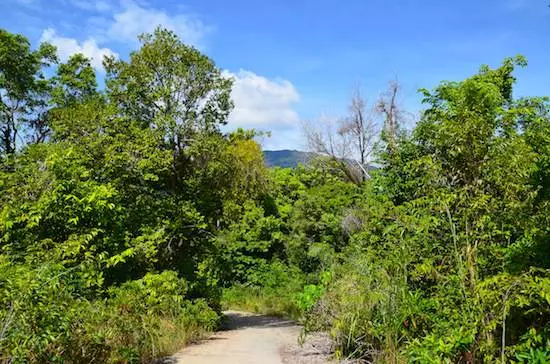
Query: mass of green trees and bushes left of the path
[[0, 29, 267, 363]]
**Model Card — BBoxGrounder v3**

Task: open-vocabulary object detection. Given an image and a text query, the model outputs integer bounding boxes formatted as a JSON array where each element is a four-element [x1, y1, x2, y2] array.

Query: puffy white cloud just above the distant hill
[[224, 70, 300, 148]]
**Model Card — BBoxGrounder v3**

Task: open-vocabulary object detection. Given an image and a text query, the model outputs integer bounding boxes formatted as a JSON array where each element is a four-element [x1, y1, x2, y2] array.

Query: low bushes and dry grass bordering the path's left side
[[0, 261, 218, 363]]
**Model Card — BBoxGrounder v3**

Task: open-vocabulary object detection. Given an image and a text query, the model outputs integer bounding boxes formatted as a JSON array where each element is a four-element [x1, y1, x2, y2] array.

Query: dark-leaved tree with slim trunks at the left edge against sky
[[0, 29, 57, 155]]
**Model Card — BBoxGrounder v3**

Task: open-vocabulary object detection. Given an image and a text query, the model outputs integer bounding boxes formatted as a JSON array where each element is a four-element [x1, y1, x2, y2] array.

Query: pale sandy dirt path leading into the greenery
[[172, 311, 332, 364]]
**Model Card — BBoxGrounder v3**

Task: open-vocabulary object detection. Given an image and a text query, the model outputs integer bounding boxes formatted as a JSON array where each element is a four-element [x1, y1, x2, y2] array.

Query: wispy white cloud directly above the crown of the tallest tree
[[108, 0, 210, 46]]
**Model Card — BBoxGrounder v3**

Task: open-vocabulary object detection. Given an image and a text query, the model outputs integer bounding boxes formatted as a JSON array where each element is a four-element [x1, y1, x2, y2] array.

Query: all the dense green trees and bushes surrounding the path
[[0, 29, 550, 363]]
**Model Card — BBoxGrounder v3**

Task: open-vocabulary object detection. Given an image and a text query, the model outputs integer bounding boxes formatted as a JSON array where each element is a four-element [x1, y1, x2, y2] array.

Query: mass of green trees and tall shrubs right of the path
[[304, 57, 550, 363]]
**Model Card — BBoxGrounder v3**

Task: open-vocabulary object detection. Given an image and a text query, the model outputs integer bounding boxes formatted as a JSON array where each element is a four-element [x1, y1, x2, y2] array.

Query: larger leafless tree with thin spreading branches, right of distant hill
[[304, 89, 377, 184]]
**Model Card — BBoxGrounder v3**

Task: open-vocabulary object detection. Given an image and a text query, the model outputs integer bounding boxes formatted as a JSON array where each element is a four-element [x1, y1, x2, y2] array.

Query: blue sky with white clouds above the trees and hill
[[0, 0, 550, 149]]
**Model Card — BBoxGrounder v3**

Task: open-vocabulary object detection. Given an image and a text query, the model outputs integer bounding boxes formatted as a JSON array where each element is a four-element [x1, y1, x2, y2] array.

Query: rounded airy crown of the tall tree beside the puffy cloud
[[105, 28, 232, 154]]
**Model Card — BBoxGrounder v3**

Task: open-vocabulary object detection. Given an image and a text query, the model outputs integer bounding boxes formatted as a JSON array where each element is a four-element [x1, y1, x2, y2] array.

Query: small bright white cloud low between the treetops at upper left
[[40, 28, 118, 69]]
